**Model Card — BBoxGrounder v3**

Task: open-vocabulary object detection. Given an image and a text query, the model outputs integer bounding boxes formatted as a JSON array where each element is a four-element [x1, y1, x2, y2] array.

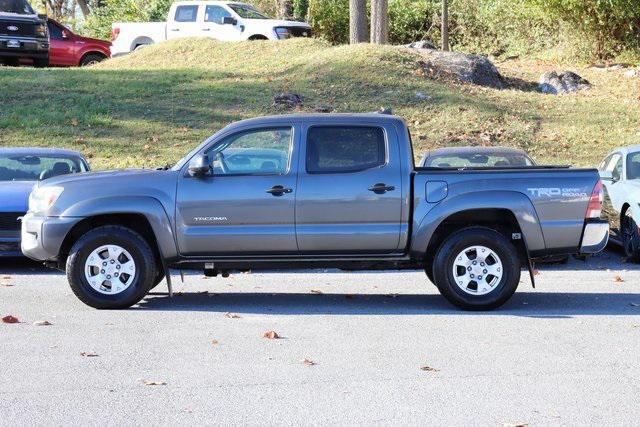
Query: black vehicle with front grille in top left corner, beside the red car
[[0, 0, 49, 67]]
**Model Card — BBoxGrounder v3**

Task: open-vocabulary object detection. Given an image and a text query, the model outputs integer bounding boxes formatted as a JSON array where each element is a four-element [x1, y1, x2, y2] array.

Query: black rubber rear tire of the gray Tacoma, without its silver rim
[[433, 227, 521, 310]]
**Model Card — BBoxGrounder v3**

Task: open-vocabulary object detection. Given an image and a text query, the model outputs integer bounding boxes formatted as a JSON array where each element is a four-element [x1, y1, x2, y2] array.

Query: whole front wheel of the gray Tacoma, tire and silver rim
[[66, 225, 158, 309]]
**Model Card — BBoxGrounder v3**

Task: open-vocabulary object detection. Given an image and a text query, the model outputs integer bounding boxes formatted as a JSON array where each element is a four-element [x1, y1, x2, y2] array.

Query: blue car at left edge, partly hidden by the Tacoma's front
[[0, 148, 89, 257]]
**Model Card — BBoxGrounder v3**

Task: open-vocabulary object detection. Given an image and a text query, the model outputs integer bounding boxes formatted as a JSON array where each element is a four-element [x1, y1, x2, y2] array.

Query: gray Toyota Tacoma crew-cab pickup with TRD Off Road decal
[[22, 114, 609, 310]]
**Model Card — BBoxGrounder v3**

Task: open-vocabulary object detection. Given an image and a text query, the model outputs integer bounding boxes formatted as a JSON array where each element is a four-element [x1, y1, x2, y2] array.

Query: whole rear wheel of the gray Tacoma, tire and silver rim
[[433, 227, 521, 310]]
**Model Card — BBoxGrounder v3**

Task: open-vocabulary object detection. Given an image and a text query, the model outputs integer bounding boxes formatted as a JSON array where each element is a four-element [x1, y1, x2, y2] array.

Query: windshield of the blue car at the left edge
[[0, 155, 87, 181]]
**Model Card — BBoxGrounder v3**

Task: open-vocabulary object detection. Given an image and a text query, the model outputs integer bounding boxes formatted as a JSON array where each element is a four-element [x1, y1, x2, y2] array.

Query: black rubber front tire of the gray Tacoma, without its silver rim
[[66, 225, 158, 309]]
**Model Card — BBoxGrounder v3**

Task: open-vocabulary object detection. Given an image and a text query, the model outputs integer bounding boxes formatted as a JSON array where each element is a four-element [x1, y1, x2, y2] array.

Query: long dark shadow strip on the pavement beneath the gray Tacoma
[[138, 292, 640, 319]]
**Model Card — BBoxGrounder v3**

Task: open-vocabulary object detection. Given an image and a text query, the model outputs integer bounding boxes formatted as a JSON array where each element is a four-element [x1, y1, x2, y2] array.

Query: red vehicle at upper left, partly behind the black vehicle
[[48, 18, 111, 67]]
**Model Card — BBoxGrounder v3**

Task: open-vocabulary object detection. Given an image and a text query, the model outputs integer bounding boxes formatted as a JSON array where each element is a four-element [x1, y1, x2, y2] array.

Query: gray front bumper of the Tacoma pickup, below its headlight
[[21, 213, 82, 261]]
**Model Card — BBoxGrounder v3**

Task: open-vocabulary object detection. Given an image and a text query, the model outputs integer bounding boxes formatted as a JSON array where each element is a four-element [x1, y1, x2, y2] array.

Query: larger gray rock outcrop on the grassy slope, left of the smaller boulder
[[407, 43, 505, 89]]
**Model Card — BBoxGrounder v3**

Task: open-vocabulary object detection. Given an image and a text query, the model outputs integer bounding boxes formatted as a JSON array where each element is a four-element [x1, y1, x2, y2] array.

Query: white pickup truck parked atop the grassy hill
[[111, 1, 311, 57]]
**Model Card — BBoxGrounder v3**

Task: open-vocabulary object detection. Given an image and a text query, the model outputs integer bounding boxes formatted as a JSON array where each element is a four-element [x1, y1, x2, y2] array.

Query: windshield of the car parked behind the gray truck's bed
[[423, 153, 535, 168]]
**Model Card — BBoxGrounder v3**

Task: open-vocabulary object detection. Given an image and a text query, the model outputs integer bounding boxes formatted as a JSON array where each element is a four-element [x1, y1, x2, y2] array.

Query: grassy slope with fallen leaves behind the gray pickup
[[0, 39, 640, 169]]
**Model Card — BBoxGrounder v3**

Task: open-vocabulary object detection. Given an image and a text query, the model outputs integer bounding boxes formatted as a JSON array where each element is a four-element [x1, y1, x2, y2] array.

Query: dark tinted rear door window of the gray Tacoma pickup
[[306, 125, 387, 174]]
